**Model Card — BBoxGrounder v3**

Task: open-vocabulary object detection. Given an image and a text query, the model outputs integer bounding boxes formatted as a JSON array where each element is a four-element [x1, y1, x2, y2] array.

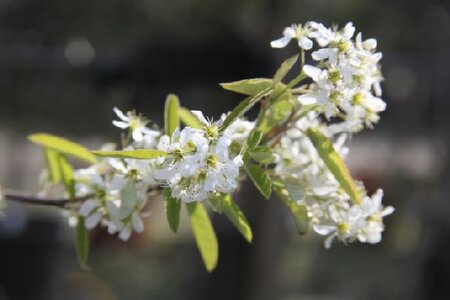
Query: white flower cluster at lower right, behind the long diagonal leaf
[[275, 112, 394, 248]]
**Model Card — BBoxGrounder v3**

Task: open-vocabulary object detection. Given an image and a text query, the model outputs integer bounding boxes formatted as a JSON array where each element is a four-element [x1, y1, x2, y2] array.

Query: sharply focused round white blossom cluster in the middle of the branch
[[154, 111, 243, 202]]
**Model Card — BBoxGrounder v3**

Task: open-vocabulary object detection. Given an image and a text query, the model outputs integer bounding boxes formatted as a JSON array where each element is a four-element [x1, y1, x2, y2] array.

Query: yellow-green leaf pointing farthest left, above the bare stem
[[28, 133, 96, 163]]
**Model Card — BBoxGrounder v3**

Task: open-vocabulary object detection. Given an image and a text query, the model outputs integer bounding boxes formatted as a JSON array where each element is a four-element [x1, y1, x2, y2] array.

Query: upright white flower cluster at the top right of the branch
[[272, 22, 386, 132]]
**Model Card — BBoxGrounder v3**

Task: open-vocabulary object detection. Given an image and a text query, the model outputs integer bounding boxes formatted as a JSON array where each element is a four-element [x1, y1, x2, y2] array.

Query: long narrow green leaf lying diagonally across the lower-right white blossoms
[[306, 128, 362, 205]]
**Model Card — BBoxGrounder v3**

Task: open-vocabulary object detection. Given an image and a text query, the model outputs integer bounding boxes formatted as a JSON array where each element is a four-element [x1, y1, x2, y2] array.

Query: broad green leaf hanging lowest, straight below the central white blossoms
[[187, 202, 219, 272]]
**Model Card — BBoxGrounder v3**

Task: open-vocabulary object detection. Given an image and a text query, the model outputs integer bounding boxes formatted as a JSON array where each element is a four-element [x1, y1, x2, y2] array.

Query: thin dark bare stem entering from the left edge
[[0, 190, 92, 208]]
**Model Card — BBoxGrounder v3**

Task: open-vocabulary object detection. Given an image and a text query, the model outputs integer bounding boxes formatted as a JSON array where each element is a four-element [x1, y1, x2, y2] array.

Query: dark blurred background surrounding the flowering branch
[[0, 0, 450, 300]]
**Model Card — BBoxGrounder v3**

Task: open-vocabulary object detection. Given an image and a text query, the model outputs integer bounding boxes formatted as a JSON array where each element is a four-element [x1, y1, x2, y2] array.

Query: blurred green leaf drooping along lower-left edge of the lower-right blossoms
[[273, 177, 311, 234]]
